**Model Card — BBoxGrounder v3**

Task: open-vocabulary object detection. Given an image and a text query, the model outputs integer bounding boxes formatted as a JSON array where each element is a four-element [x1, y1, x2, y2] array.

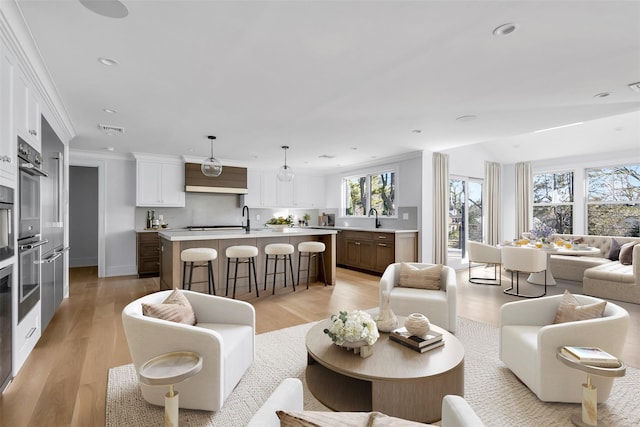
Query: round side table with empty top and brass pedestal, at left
[[139, 351, 202, 427]]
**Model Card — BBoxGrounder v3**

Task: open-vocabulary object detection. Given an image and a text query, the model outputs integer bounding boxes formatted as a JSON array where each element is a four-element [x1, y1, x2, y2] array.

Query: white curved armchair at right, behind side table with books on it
[[500, 295, 629, 403]]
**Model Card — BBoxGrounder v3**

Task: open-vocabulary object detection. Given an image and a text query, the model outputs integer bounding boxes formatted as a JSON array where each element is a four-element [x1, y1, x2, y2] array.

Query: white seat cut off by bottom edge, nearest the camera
[[247, 378, 484, 427]]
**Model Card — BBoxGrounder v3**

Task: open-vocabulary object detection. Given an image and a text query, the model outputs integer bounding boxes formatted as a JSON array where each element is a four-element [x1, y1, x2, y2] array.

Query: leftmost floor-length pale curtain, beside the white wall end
[[433, 153, 449, 265]]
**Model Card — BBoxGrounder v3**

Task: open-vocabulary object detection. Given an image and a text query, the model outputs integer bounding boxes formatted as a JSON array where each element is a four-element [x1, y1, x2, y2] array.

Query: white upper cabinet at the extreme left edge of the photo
[[0, 44, 17, 187]]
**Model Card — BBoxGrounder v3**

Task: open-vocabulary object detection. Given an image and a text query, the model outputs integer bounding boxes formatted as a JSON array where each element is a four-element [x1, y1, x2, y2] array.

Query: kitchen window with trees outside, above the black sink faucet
[[342, 171, 396, 217]]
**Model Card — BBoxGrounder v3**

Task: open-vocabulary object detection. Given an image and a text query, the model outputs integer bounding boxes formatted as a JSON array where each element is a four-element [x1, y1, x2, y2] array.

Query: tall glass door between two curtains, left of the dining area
[[448, 178, 483, 258]]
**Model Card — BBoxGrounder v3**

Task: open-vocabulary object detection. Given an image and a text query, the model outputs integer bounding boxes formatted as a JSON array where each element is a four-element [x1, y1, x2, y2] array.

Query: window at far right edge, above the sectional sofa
[[586, 165, 640, 236]]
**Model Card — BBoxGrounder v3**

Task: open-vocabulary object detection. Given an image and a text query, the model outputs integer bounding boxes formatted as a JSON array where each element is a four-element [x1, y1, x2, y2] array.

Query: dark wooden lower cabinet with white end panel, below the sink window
[[336, 230, 418, 274]]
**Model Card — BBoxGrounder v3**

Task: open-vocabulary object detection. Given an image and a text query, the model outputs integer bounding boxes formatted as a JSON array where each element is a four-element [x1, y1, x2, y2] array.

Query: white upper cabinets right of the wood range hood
[[245, 169, 325, 208]]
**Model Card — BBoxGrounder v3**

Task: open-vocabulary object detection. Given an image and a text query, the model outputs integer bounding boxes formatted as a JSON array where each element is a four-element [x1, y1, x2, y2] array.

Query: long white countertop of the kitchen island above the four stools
[[158, 227, 337, 242]]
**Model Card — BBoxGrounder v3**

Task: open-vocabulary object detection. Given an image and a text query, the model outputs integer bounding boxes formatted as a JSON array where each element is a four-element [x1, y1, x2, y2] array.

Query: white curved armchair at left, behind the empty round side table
[[122, 290, 255, 411]]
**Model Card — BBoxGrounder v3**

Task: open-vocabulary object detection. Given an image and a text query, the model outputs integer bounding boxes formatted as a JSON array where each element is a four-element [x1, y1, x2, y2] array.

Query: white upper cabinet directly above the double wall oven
[[13, 67, 42, 151]]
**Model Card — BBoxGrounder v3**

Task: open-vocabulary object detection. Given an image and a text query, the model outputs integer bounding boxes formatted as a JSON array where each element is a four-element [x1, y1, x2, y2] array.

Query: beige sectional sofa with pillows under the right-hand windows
[[550, 234, 640, 304]]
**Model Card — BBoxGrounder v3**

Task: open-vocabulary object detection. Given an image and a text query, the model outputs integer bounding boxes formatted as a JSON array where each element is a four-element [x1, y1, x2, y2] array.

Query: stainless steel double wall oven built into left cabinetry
[[18, 137, 47, 322]]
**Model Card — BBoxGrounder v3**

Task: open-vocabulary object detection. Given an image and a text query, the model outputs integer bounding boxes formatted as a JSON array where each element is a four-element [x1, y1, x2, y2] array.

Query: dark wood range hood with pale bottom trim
[[184, 163, 249, 194]]
